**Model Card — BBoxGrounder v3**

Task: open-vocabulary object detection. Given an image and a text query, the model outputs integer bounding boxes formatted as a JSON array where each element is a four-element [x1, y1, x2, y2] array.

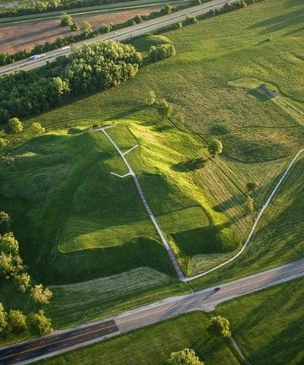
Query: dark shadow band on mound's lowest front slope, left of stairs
[[35, 237, 175, 285]]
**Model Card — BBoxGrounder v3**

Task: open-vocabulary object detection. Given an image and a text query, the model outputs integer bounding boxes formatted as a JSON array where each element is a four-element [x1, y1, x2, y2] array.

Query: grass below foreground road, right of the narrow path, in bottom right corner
[[216, 279, 304, 365]]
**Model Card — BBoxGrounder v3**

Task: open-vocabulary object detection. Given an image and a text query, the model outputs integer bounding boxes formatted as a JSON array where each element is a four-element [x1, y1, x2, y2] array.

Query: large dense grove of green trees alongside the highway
[[0, 40, 142, 123]]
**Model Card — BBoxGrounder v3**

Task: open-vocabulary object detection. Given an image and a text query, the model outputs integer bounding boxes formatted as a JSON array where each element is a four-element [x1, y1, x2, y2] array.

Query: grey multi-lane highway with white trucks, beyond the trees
[[0, 0, 234, 75]]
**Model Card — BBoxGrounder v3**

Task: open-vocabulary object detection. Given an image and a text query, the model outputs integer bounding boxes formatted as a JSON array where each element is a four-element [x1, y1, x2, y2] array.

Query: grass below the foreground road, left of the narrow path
[[38, 312, 239, 365]]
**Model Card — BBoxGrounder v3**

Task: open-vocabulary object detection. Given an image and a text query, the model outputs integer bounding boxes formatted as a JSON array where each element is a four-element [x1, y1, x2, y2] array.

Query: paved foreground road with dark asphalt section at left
[[0, 259, 304, 365]]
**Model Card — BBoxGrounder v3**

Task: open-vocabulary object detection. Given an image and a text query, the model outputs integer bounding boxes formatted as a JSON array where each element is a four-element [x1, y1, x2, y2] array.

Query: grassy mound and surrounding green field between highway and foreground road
[[0, 0, 304, 336]]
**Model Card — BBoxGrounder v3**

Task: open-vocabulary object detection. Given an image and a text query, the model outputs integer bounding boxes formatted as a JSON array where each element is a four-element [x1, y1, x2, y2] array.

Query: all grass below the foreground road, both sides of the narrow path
[[40, 279, 304, 365]]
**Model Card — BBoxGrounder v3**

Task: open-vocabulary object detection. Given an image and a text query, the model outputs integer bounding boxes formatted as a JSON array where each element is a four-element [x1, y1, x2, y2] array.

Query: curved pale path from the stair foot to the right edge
[[184, 148, 304, 281]]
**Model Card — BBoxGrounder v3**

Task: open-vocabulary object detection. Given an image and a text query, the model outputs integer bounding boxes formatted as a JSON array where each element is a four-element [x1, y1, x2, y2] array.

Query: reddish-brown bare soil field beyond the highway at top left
[[0, 7, 159, 54]]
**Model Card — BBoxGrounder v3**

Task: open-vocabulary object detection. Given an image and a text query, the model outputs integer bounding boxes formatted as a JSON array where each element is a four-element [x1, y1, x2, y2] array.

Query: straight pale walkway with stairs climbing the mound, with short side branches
[[92, 126, 185, 281]]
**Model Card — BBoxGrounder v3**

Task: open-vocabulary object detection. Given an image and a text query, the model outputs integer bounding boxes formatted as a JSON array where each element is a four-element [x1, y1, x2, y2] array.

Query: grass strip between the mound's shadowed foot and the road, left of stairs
[[45, 267, 188, 328]]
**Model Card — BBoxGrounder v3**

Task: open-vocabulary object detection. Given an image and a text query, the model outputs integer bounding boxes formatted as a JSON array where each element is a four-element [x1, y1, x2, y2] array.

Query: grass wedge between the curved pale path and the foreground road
[[191, 156, 304, 289]]
